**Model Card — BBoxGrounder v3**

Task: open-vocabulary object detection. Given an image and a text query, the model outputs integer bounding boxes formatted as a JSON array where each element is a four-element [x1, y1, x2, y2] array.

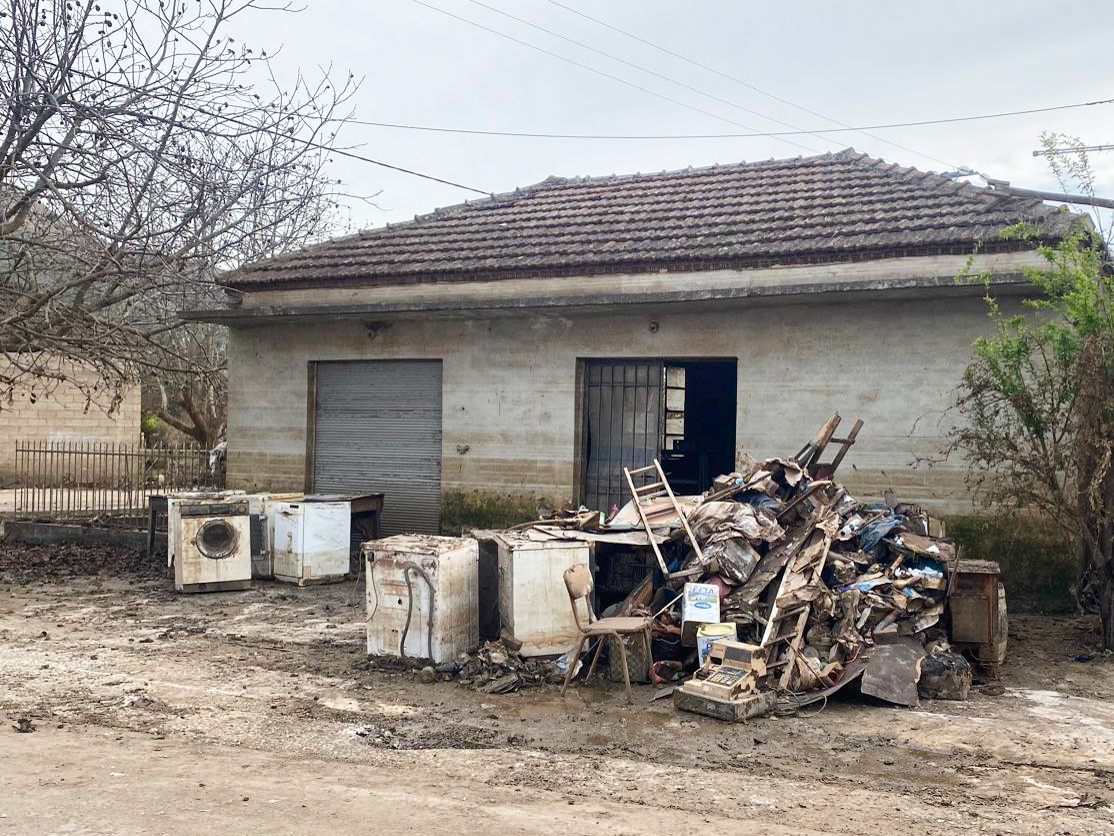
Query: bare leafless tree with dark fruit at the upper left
[[0, 0, 356, 419]]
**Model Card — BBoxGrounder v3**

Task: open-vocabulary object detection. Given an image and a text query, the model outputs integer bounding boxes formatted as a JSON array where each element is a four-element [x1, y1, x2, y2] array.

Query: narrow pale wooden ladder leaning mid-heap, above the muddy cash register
[[761, 514, 832, 689]]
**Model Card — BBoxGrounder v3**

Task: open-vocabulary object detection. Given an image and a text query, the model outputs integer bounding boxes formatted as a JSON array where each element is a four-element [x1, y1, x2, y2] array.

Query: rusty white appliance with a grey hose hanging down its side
[[362, 534, 479, 664]]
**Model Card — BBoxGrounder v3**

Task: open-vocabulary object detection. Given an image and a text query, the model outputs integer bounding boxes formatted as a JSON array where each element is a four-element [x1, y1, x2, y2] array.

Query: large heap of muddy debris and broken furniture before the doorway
[[512, 415, 970, 719]]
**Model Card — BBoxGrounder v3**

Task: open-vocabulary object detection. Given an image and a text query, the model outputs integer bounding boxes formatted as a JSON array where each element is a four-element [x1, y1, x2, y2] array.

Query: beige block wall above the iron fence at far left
[[0, 369, 140, 483]]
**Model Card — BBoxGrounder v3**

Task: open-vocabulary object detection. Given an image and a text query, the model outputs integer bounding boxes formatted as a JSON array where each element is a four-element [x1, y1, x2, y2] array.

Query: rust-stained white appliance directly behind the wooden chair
[[495, 532, 592, 657]]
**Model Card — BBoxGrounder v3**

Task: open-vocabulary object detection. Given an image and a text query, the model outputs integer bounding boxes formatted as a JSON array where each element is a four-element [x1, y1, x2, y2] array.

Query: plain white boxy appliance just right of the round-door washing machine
[[267, 499, 352, 586]]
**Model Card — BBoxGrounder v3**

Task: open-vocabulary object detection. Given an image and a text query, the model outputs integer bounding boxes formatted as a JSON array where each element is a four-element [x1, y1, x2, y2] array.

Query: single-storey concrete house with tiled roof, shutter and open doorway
[[184, 149, 1072, 533]]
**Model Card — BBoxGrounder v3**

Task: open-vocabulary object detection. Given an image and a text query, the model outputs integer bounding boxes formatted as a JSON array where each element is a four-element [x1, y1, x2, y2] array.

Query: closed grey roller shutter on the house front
[[313, 360, 441, 536]]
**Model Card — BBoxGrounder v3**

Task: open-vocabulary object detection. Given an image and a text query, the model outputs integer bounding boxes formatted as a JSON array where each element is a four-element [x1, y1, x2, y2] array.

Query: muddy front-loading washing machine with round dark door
[[167, 494, 252, 592]]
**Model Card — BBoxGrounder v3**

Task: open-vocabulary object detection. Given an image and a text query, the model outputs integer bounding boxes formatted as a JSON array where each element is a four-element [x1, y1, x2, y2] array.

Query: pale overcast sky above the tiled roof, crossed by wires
[[244, 0, 1114, 226]]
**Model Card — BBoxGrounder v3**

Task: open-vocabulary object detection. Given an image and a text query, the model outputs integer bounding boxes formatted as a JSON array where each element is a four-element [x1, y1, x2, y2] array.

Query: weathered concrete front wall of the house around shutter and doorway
[[228, 294, 1011, 521]]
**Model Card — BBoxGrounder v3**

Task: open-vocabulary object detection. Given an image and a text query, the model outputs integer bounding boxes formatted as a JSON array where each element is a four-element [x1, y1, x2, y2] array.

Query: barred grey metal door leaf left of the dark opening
[[584, 360, 665, 512]]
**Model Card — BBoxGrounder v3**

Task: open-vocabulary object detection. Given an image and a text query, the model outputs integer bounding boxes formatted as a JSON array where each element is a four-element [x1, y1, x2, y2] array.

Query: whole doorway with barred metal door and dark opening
[[580, 358, 737, 512]]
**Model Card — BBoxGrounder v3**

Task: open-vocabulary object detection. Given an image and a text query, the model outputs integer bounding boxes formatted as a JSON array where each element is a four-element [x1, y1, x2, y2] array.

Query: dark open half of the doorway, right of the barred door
[[661, 360, 737, 496]]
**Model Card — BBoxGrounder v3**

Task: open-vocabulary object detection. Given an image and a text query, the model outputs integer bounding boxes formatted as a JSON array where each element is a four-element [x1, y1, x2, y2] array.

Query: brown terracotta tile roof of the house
[[222, 149, 1071, 289]]
